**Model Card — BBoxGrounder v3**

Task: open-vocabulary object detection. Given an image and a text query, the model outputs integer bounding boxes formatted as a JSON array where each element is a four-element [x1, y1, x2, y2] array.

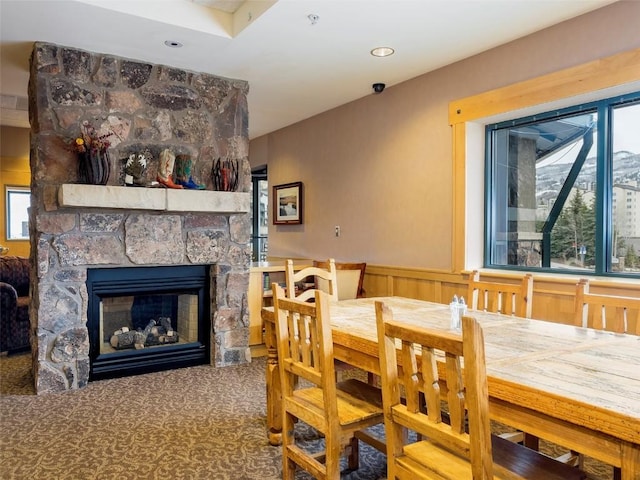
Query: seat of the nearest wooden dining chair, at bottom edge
[[397, 435, 587, 480]]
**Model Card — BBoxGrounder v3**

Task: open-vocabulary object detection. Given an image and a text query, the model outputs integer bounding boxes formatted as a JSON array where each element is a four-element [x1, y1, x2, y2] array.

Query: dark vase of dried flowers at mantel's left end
[[73, 121, 113, 185]]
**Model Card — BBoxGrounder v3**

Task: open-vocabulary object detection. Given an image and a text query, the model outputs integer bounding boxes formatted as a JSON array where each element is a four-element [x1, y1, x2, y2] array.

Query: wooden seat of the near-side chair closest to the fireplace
[[285, 379, 382, 432]]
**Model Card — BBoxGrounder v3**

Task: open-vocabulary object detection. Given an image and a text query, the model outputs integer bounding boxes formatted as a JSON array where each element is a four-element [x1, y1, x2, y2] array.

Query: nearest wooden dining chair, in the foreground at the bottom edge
[[375, 301, 586, 480]]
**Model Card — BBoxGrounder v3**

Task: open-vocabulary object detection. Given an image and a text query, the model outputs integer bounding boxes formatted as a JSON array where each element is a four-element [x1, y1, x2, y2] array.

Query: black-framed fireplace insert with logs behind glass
[[87, 265, 210, 380]]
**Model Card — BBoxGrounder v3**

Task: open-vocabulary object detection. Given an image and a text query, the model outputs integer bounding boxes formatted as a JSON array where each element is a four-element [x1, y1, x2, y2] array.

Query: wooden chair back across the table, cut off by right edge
[[574, 279, 640, 335]]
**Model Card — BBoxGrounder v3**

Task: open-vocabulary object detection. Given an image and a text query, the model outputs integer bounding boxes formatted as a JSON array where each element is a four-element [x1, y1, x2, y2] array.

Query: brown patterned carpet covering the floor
[[0, 354, 612, 480]]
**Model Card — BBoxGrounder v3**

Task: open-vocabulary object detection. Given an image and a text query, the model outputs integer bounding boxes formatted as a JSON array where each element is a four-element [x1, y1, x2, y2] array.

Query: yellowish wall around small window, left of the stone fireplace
[[0, 126, 31, 257]]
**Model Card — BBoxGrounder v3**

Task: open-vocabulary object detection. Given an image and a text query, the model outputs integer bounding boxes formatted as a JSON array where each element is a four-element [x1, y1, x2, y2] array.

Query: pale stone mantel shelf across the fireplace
[[58, 183, 251, 214]]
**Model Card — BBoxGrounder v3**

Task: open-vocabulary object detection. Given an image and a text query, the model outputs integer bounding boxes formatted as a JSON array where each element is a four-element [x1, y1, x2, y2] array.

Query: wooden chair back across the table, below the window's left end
[[467, 270, 533, 318]]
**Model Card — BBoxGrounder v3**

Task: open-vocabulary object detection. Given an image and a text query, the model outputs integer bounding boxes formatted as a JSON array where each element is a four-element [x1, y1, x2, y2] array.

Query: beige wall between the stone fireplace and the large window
[[250, 1, 640, 271]]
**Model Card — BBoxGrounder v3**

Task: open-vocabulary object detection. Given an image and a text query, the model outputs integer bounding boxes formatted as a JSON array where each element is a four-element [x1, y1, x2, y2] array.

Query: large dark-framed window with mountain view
[[485, 92, 640, 276]]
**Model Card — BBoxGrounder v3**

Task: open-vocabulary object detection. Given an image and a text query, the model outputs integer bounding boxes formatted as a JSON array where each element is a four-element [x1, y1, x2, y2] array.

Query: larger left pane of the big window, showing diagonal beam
[[491, 112, 596, 270]]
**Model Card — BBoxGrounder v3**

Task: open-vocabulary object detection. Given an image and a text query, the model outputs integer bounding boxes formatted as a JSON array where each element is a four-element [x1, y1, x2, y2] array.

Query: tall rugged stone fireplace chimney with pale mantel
[[29, 43, 251, 394]]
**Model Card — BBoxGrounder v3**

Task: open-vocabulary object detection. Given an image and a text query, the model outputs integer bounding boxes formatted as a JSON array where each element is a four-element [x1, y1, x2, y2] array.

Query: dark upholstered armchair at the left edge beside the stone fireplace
[[0, 255, 30, 353]]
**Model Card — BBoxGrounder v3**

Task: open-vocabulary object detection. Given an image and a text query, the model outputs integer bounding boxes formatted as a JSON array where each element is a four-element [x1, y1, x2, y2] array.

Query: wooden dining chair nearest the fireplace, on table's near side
[[273, 283, 384, 480]]
